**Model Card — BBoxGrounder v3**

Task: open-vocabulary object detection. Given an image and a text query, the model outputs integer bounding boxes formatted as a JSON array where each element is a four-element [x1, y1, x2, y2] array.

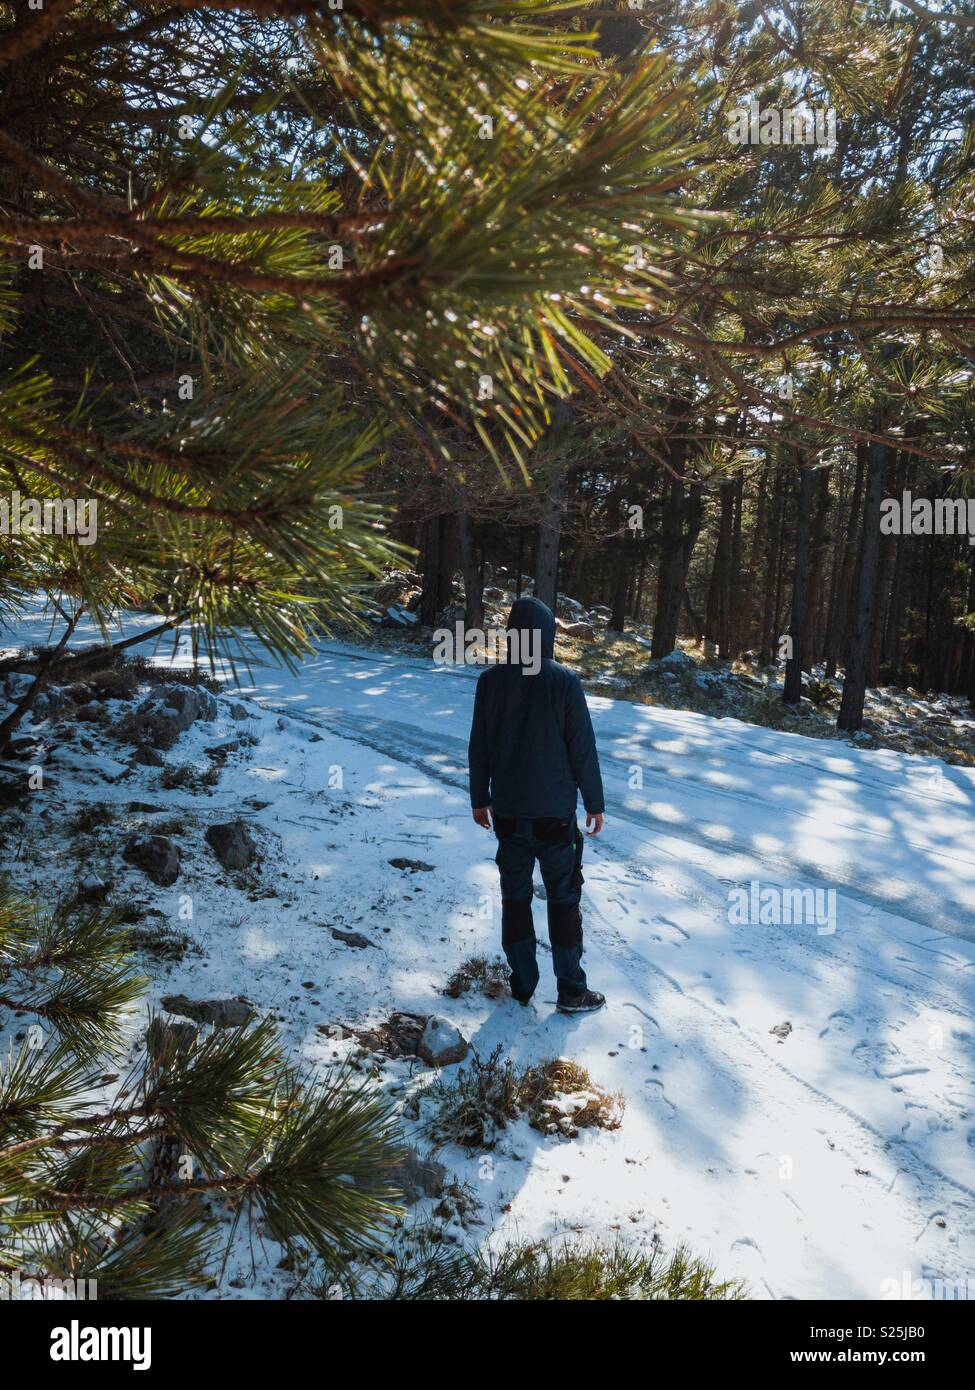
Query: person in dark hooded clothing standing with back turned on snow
[[467, 599, 606, 1013]]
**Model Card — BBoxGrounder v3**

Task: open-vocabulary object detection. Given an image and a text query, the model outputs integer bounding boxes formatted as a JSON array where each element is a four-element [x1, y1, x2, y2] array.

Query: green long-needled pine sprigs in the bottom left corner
[[0, 894, 399, 1300]]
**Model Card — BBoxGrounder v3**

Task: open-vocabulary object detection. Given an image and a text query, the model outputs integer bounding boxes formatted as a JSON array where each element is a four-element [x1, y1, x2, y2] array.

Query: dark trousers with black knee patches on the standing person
[[494, 816, 586, 1001]]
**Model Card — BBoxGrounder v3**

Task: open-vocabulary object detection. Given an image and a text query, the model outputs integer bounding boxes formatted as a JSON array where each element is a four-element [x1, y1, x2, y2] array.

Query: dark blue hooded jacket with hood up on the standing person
[[467, 599, 605, 820]]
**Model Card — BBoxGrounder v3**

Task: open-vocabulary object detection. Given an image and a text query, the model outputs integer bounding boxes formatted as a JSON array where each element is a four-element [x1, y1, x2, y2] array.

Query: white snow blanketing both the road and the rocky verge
[[0, 600, 975, 1298]]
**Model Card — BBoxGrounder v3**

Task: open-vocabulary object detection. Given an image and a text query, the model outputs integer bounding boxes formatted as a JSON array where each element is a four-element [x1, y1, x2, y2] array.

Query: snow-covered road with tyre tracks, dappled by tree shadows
[[226, 648, 975, 1298]]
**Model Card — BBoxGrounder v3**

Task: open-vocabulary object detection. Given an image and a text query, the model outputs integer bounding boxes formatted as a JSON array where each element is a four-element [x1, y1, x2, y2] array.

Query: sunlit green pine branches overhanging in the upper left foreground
[[0, 0, 717, 735]]
